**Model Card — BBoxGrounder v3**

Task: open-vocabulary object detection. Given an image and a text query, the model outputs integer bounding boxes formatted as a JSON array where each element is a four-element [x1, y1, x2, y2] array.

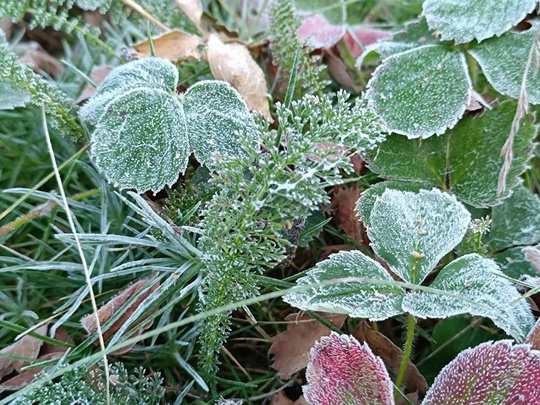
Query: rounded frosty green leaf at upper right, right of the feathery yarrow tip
[[367, 45, 472, 138]]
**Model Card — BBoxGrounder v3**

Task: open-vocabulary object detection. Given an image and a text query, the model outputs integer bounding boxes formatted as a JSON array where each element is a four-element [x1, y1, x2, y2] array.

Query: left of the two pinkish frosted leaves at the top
[[296, 15, 345, 49]]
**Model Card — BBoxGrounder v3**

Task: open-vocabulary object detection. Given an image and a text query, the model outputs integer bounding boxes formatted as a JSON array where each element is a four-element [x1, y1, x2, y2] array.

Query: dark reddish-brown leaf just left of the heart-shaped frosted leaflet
[[332, 184, 363, 243]]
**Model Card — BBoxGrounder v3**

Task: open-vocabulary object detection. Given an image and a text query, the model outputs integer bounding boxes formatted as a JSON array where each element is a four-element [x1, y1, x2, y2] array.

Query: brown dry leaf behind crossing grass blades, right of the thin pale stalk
[[81, 277, 159, 354]]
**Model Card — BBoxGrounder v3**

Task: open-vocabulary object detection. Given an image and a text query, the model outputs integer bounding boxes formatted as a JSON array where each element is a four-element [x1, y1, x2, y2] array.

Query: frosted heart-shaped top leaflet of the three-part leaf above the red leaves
[[368, 189, 471, 284]]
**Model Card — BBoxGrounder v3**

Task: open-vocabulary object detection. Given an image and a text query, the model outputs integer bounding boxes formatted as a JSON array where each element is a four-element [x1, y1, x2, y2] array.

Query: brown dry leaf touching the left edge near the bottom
[[0, 325, 48, 379]]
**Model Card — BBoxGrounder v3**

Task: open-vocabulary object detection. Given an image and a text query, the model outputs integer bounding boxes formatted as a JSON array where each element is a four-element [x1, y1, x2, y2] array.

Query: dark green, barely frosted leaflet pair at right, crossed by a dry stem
[[365, 101, 537, 207]]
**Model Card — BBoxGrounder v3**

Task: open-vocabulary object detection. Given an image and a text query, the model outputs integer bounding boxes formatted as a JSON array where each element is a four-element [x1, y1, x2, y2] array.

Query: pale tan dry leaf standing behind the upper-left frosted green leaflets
[[207, 34, 273, 122]]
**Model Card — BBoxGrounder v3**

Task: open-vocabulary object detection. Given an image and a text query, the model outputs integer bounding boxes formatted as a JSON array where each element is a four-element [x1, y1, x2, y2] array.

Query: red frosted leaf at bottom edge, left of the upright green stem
[[303, 332, 394, 405]]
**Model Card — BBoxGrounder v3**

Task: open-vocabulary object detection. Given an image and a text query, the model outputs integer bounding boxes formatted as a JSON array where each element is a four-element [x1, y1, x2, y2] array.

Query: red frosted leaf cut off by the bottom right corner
[[422, 340, 540, 405]]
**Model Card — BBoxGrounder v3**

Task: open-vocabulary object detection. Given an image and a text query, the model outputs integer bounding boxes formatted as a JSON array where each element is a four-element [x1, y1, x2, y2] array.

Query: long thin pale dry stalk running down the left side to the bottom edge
[[41, 106, 111, 405]]
